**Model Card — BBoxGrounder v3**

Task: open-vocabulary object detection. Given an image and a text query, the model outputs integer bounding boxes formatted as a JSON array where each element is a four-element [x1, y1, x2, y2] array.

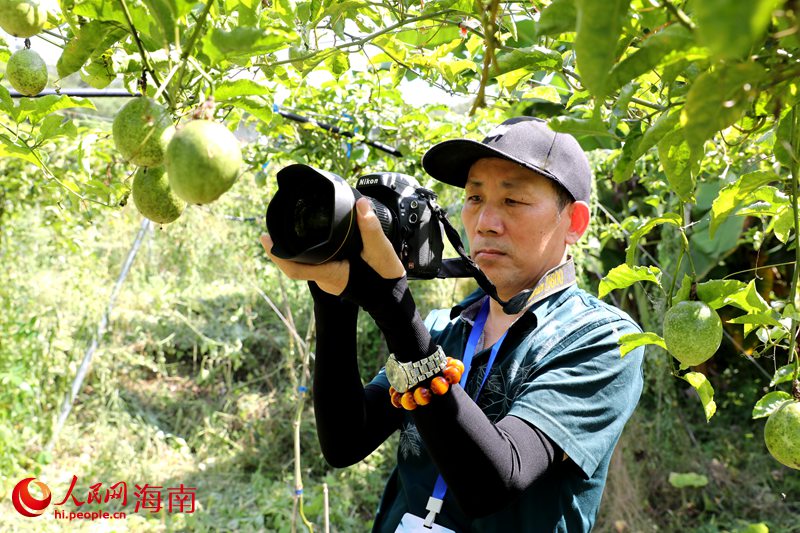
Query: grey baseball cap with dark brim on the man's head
[[422, 117, 592, 203]]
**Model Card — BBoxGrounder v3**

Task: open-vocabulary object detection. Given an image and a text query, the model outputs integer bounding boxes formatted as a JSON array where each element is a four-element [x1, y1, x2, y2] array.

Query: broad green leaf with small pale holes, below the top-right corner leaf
[[681, 63, 766, 157]]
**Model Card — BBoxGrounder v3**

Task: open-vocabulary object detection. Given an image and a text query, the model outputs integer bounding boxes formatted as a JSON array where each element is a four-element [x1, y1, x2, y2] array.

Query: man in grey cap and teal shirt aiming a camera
[[262, 117, 644, 533]]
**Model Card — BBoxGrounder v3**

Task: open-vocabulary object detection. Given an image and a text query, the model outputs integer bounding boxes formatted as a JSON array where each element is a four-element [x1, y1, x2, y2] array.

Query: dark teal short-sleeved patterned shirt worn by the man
[[372, 285, 644, 533]]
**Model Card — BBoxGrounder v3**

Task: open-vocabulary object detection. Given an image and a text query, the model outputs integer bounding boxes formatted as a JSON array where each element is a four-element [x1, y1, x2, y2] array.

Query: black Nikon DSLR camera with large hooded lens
[[266, 164, 443, 279]]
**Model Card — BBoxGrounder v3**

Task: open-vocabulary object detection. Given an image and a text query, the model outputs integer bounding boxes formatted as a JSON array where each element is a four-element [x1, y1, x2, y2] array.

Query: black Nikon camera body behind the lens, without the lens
[[356, 172, 444, 279]]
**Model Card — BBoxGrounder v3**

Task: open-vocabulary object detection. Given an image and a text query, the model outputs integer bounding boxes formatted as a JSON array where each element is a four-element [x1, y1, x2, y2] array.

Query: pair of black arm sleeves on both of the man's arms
[[310, 261, 562, 517]]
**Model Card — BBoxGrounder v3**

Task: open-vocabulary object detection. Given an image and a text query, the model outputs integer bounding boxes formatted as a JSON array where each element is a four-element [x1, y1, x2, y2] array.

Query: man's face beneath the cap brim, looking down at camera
[[461, 158, 572, 299]]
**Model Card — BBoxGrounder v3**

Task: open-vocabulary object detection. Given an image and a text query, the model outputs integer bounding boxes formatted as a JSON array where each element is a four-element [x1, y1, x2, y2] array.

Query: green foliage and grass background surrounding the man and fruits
[[0, 0, 800, 532]]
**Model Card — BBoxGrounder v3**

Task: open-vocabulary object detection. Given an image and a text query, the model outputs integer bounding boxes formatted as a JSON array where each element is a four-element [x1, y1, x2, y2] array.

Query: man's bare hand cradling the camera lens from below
[[261, 198, 406, 296]]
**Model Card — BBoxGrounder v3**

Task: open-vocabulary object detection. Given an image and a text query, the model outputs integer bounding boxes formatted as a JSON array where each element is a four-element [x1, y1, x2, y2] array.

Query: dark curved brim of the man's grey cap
[[422, 139, 558, 189]]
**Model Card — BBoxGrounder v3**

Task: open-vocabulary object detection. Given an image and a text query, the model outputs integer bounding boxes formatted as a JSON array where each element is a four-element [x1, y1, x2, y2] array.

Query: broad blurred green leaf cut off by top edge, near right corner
[[692, 0, 783, 59]]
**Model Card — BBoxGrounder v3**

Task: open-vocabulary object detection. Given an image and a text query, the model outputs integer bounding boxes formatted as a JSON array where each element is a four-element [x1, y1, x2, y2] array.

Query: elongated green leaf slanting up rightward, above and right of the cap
[[608, 24, 694, 91]]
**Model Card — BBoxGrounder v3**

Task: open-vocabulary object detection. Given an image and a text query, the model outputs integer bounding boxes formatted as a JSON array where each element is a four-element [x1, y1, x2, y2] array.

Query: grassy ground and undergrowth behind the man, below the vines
[[0, 180, 800, 533]]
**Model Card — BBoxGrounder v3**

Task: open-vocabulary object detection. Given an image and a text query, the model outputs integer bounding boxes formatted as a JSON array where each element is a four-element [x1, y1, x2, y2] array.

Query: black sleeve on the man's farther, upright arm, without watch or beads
[[309, 282, 403, 468]]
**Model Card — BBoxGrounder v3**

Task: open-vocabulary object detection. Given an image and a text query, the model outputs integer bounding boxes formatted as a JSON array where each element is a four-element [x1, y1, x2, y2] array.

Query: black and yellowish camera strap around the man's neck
[[428, 201, 575, 315]]
